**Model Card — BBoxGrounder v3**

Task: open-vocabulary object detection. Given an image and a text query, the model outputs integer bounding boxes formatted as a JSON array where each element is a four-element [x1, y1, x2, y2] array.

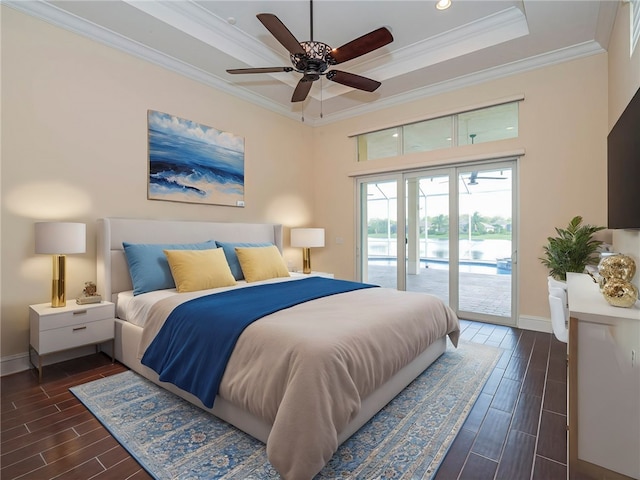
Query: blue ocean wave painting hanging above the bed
[[147, 110, 244, 207]]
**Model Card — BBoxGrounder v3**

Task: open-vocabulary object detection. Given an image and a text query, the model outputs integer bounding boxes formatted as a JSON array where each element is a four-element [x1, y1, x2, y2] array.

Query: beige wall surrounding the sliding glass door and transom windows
[[314, 54, 608, 322]]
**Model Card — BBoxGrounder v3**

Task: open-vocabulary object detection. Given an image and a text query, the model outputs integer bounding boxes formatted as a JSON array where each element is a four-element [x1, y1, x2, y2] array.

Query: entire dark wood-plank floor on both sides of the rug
[[0, 320, 567, 480]]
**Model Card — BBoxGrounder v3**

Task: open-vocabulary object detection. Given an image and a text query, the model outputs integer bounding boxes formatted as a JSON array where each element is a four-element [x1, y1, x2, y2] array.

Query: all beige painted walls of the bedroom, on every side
[[0, 4, 640, 368]]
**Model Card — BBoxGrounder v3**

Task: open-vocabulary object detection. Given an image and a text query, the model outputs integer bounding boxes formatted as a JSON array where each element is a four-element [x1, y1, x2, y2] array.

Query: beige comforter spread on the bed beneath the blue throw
[[139, 278, 459, 480]]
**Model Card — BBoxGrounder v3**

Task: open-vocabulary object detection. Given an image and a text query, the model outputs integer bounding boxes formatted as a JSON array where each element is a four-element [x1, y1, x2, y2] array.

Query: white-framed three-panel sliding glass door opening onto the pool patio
[[357, 160, 516, 324]]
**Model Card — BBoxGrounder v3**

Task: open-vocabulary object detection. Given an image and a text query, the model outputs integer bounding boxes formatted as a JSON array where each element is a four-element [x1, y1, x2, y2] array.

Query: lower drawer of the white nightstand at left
[[33, 318, 115, 355]]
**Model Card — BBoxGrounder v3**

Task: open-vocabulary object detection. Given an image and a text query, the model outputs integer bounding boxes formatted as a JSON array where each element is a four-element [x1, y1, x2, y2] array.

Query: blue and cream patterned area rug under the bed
[[70, 342, 501, 480]]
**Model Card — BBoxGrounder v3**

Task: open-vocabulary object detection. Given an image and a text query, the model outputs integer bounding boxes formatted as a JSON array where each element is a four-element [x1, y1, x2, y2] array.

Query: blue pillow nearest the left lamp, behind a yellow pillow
[[122, 240, 217, 295]]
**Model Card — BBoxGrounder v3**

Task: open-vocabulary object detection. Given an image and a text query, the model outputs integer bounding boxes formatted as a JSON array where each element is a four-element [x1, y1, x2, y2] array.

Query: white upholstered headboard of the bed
[[97, 218, 282, 301]]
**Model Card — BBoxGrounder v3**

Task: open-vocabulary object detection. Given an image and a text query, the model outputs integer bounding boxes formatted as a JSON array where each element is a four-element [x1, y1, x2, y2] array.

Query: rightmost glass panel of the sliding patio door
[[458, 165, 515, 323]]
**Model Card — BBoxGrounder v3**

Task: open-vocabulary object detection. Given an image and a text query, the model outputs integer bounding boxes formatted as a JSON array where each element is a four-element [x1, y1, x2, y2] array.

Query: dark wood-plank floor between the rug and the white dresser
[[435, 321, 567, 480]]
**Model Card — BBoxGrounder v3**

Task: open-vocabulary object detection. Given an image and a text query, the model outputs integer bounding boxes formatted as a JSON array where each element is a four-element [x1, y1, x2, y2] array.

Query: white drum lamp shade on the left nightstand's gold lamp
[[35, 222, 87, 255]]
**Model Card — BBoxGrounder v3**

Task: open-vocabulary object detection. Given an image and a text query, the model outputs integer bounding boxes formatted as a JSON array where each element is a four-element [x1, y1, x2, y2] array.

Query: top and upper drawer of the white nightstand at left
[[31, 302, 115, 332]]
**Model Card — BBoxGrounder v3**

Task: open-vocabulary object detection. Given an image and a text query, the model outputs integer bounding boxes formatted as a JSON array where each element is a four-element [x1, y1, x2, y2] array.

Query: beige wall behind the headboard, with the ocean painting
[[0, 6, 314, 359]]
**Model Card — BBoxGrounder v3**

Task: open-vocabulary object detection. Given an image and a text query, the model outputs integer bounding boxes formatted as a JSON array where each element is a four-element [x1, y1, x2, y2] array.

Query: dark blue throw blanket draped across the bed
[[142, 277, 375, 408]]
